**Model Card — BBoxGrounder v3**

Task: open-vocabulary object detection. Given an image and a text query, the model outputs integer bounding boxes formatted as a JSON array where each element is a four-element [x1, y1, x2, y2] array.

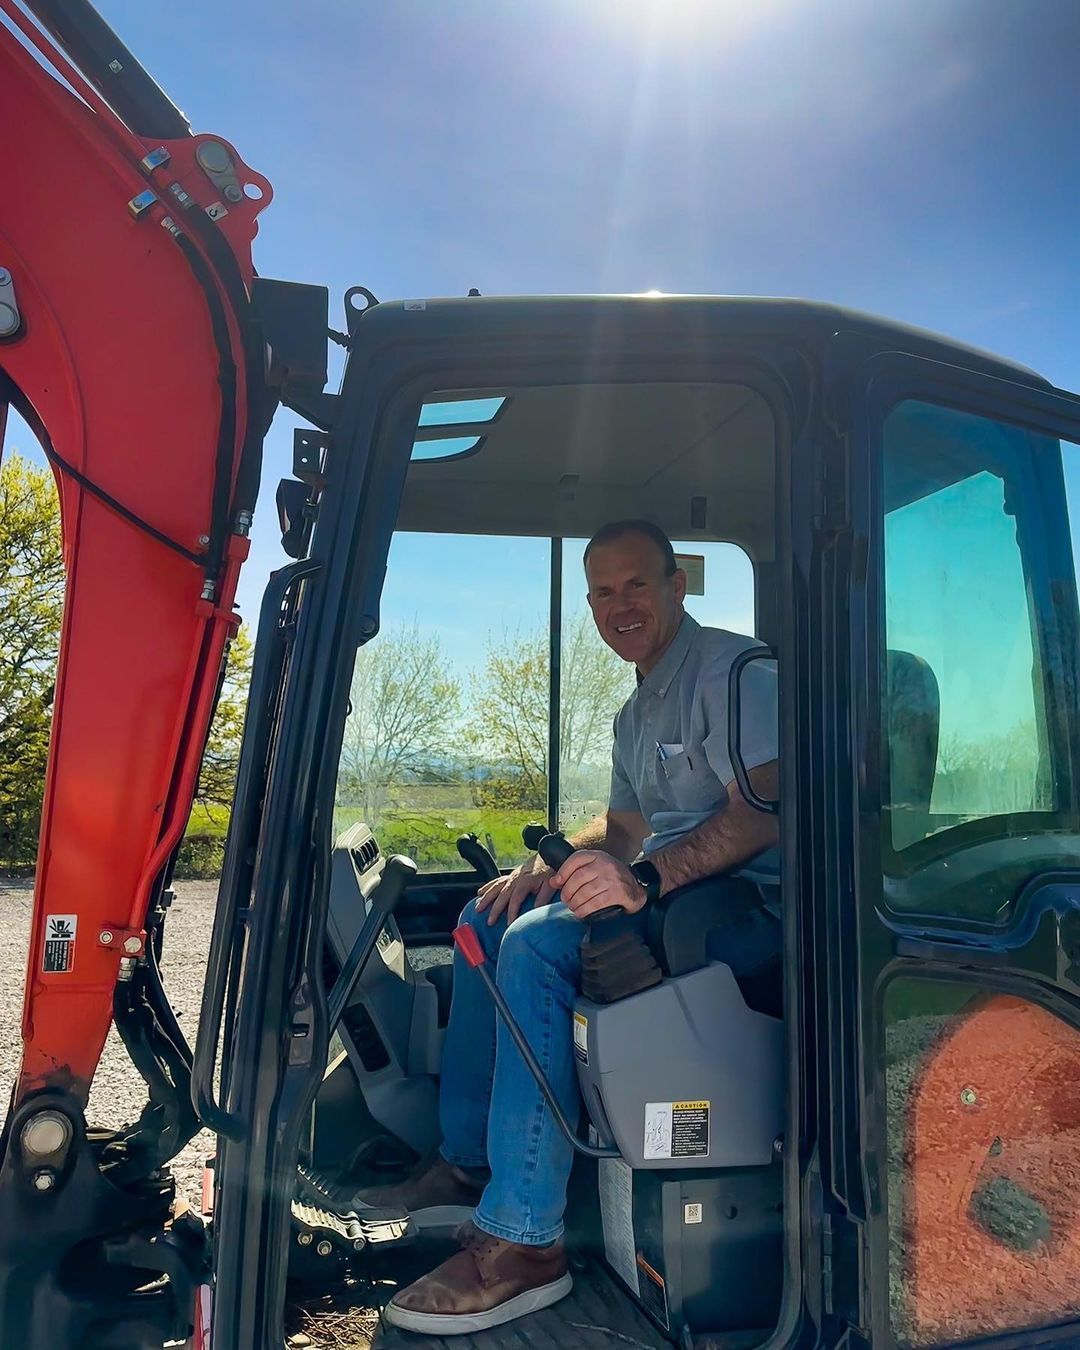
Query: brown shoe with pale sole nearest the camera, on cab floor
[[383, 1223, 574, 1337]]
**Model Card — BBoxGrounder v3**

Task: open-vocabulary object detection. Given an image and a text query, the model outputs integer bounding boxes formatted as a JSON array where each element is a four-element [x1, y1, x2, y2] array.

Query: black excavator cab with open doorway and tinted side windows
[[208, 297, 1080, 1346]]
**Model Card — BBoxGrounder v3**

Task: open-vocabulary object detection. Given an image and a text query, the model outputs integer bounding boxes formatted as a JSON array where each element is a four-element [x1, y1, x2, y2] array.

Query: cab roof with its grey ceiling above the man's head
[[352, 296, 1048, 562]]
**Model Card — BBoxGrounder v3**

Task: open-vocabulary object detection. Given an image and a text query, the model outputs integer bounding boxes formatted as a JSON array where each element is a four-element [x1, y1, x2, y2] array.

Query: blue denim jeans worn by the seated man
[[439, 900, 775, 1246]]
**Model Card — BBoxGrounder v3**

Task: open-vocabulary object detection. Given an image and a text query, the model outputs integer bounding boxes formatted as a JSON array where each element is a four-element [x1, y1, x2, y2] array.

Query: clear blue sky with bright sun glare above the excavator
[[11, 0, 1080, 669]]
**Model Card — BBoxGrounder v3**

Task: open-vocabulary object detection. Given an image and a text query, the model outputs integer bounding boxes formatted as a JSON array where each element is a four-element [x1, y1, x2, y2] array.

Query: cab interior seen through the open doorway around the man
[[225, 342, 784, 1345]]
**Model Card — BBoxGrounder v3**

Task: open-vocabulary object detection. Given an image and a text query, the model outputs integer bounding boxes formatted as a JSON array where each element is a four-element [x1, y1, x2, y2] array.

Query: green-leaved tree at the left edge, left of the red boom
[[0, 454, 63, 864]]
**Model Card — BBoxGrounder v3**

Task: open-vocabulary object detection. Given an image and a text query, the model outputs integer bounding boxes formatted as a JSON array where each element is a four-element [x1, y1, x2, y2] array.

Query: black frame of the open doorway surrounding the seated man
[[213, 301, 817, 1350]]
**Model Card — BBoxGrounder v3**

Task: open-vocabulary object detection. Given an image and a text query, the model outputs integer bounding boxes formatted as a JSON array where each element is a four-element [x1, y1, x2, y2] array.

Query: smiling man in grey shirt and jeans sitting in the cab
[[358, 520, 780, 1335]]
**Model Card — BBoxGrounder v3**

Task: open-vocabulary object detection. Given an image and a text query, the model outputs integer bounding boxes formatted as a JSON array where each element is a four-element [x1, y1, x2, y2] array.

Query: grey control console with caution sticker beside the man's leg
[[574, 855, 786, 1328]]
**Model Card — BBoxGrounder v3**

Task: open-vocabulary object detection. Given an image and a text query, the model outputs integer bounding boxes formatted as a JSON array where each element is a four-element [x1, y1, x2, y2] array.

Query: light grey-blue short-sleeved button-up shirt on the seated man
[[609, 614, 778, 855]]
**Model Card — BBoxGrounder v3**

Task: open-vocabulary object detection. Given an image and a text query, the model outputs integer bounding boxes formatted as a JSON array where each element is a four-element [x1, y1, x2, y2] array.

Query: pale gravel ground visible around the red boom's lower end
[[0, 880, 217, 1204]]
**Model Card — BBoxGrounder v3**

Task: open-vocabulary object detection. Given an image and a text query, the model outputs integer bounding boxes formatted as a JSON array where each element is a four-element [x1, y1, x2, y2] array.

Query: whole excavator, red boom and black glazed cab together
[[0, 0, 1080, 1350]]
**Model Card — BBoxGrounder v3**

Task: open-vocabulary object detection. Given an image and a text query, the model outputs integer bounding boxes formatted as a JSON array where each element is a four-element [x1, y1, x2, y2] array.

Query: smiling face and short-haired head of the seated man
[[585, 533, 686, 675]]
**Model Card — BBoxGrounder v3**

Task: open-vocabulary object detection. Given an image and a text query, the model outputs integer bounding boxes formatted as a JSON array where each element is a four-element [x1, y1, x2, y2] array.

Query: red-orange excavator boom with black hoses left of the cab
[[0, 0, 282, 1346]]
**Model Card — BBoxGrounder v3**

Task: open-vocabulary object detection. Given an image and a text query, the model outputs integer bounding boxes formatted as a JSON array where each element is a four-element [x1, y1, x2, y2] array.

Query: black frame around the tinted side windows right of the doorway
[[824, 335, 1080, 1347]]
